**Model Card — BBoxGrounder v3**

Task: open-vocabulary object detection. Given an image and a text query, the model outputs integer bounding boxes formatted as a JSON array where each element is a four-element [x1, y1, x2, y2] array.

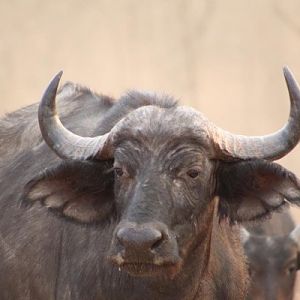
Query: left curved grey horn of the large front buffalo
[[38, 71, 109, 159]]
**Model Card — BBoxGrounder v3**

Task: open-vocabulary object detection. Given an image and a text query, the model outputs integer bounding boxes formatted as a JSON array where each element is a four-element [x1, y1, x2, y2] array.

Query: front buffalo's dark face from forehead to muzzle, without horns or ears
[[104, 117, 214, 276]]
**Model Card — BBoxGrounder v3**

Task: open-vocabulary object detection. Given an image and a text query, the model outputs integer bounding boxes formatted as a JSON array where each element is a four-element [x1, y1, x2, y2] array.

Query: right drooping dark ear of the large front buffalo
[[217, 159, 300, 223]]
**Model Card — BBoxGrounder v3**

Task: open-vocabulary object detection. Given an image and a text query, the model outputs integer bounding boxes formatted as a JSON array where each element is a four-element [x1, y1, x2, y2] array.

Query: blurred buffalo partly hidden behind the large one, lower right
[[241, 211, 300, 300]]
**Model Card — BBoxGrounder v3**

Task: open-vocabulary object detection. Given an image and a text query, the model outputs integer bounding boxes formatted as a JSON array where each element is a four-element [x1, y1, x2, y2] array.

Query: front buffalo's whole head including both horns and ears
[[25, 69, 300, 277]]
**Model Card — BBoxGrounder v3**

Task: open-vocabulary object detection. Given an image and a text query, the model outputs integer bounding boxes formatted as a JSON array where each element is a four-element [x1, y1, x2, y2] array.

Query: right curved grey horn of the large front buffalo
[[210, 67, 300, 160]]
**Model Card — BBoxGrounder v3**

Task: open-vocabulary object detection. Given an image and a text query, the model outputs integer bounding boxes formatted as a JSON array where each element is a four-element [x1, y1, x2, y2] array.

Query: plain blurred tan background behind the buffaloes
[[0, 0, 300, 299]]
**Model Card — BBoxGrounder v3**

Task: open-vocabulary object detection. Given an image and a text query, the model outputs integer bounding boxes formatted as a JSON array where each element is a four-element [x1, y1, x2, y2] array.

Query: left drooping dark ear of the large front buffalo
[[22, 161, 114, 223]]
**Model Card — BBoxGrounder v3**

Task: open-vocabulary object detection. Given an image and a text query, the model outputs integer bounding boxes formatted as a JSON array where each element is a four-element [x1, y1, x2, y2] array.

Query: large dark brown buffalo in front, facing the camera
[[0, 68, 300, 300]]
